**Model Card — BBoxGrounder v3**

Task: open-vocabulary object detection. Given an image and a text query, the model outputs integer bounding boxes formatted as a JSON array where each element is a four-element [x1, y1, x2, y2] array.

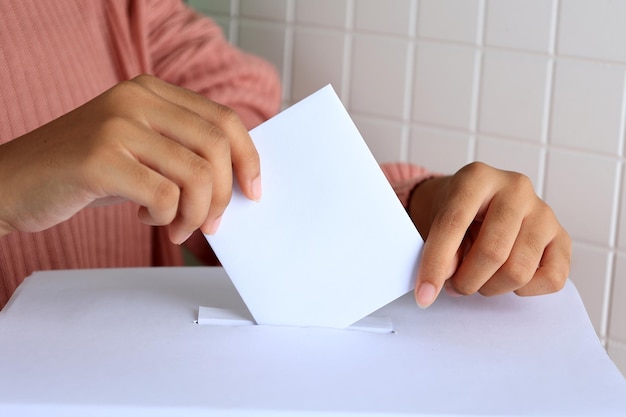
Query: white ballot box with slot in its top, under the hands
[[0, 267, 626, 417]]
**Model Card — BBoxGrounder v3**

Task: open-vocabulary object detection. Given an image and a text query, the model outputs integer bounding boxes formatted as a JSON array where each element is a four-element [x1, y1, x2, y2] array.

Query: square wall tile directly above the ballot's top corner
[[291, 28, 345, 102]]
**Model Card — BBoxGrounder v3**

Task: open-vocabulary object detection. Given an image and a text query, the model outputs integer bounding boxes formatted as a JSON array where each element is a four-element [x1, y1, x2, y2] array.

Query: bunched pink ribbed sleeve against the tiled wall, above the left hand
[[137, 0, 281, 129]]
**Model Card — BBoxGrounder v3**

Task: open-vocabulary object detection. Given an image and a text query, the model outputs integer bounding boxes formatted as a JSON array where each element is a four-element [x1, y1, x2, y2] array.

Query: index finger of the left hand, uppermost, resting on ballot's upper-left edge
[[133, 76, 261, 201]]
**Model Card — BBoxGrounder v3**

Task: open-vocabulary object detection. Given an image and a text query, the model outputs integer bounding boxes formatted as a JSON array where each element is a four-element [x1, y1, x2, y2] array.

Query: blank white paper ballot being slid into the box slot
[[207, 86, 423, 328]]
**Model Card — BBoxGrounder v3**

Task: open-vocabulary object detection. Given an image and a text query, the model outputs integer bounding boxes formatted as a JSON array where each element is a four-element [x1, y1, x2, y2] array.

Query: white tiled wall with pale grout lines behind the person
[[189, 0, 626, 373]]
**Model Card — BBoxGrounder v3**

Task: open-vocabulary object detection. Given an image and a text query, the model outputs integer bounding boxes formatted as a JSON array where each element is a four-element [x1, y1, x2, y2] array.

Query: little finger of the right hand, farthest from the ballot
[[515, 230, 572, 296]]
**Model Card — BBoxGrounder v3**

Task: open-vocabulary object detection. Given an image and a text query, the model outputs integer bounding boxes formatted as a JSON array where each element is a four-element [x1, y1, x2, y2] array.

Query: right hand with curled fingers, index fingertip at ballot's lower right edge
[[409, 163, 572, 308]]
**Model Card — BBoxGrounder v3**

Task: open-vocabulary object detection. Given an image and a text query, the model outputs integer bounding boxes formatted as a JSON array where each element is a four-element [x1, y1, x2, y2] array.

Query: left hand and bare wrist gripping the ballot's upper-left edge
[[0, 75, 261, 244]]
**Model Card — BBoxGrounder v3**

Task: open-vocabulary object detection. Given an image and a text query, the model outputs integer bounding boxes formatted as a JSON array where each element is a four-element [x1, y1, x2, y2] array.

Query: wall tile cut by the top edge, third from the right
[[417, 0, 482, 44]]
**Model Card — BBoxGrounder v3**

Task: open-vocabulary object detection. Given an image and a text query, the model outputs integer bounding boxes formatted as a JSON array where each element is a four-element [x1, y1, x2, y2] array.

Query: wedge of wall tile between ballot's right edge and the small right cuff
[[352, 115, 403, 164]]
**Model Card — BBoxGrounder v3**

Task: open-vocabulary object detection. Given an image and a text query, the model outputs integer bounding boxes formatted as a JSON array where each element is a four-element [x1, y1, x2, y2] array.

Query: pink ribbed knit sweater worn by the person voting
[[0, 0, 425, 308]]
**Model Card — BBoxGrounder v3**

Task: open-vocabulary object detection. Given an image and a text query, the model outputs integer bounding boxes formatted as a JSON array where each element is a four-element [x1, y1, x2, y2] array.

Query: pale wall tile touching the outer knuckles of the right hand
[[545, 149, 619, 246]]
